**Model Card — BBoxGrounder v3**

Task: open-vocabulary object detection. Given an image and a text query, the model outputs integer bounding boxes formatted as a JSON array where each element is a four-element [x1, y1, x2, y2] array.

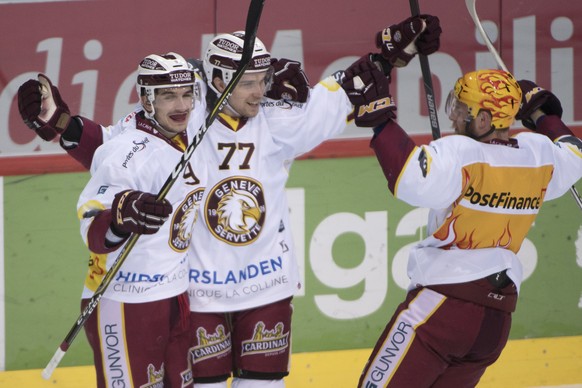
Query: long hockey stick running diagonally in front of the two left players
[[42, 0, 265, 380]]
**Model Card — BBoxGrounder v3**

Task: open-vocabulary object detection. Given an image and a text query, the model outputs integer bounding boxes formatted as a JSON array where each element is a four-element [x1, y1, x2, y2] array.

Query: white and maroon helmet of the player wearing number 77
[[202, 31, 271, 95]]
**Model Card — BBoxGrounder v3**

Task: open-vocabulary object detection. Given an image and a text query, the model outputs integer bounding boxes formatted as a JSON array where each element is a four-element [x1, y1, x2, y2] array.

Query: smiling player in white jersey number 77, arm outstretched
[[14, 13, 440, 388]]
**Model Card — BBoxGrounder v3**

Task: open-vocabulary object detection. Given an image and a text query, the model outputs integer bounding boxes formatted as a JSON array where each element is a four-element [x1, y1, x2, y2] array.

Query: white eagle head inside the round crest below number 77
[[216, 189, 261, 233]]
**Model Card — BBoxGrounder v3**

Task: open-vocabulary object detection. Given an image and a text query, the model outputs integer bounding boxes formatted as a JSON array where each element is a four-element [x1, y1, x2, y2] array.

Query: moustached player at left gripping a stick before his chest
[[78, 53, 203, 388]]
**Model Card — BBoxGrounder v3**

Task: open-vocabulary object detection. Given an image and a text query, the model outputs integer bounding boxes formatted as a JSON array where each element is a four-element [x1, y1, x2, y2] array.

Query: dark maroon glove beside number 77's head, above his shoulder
[[266, 58, 309, 102]]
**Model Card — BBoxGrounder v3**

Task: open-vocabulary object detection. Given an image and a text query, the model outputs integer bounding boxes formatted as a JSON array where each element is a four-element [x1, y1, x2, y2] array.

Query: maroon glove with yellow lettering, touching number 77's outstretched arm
[[342, 54, 396, 127]]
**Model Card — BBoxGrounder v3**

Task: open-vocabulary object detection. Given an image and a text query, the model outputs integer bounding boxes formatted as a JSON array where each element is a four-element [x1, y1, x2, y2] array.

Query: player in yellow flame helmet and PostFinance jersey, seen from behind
[[346, 28, 582, 388]]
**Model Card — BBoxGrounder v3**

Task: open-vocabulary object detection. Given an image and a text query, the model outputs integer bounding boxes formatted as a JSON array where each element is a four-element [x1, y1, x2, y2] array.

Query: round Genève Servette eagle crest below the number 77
[[205, 176, 266, 245]]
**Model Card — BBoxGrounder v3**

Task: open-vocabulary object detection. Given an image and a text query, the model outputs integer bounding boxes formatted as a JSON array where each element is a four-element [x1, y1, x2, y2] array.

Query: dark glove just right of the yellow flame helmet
[[515, 80, 562, 131]]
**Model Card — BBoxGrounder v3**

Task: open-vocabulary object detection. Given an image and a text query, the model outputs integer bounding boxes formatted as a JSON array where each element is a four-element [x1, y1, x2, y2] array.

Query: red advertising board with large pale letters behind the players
[[0, 0, 582, 161]]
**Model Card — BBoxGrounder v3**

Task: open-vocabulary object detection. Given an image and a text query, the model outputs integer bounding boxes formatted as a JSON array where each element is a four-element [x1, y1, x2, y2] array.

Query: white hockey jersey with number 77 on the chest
[[189, 77, 352, 312]]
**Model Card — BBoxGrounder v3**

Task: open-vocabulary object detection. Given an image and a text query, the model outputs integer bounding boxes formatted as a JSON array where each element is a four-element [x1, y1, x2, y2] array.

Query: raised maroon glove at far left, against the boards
[[18, 74, 71, 141]]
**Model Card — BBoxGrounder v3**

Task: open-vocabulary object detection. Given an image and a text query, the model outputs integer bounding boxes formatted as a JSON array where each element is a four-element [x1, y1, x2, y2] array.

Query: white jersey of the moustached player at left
[[77, 115, 209, 303]]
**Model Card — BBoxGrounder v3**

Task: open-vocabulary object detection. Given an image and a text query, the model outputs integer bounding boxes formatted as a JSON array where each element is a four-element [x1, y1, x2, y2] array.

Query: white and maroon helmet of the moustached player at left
[[136, 52, 195, 118]]
